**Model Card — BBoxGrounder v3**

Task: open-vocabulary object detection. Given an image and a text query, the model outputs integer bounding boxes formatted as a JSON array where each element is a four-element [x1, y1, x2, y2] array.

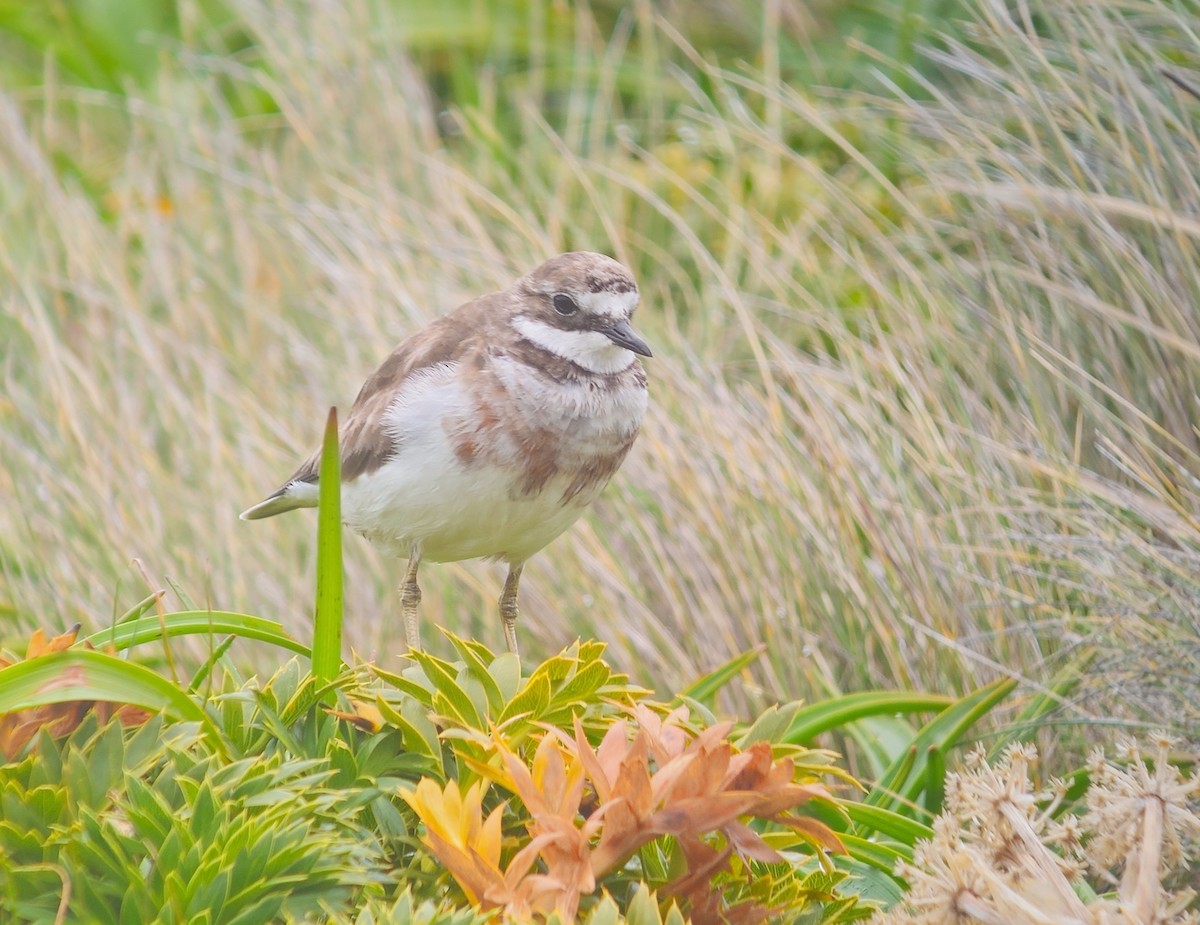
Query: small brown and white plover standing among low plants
[[241, 251, 653, 653]]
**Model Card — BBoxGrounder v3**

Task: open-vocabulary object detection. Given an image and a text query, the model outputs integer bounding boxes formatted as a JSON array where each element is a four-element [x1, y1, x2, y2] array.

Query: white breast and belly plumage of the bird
[[342, 352, 646, 561]]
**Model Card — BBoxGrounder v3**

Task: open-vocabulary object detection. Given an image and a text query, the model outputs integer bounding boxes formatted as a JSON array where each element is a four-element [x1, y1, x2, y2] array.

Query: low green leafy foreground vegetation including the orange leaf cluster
[[0, 597, 1046, 923]]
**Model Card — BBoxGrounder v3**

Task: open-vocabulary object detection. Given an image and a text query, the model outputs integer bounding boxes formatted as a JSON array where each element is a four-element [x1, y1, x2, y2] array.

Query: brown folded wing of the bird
[[281, 293, 503, 491]]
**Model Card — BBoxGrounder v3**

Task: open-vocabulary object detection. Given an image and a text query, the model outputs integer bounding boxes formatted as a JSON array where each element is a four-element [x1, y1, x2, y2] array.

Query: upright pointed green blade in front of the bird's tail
[[312, 408, 342, 680]]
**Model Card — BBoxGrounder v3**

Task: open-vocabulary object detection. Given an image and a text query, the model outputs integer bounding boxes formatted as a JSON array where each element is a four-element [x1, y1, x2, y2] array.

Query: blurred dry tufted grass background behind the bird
[[0, 0, 1200, 738]]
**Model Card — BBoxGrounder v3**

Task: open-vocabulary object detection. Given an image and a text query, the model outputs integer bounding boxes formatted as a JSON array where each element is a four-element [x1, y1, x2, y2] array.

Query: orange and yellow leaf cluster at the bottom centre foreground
[[403, 705, 845, 925]]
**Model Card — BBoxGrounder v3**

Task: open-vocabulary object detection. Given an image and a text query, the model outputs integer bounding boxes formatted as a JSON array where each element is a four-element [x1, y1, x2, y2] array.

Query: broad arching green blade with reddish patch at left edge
[[0, 649, 224, 751]]
